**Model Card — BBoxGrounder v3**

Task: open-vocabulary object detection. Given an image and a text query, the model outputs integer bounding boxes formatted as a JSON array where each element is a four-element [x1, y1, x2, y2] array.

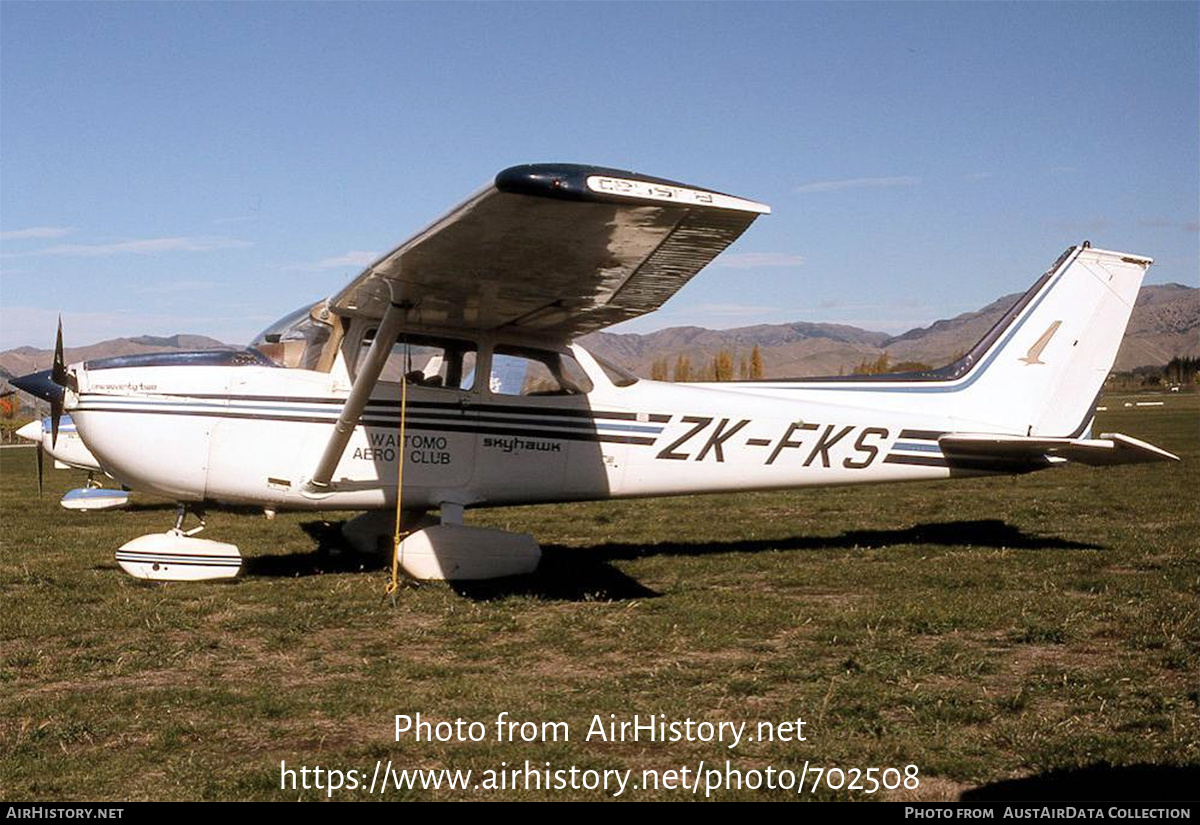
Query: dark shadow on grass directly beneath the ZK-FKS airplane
[[229, 519, 1102, 601]]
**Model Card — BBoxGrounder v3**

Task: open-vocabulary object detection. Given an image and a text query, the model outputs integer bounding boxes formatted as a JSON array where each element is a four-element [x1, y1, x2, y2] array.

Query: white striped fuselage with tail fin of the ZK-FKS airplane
[[65, 247, 1150, 518]]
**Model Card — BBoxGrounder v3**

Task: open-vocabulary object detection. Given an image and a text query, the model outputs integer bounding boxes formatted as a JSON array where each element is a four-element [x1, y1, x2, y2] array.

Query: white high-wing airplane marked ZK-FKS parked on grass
[[4, 164, 1178, 586]]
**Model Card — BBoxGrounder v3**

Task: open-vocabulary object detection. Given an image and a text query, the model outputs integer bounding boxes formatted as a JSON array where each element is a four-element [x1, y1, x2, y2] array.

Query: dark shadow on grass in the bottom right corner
[[960, 763, 1200, 802]]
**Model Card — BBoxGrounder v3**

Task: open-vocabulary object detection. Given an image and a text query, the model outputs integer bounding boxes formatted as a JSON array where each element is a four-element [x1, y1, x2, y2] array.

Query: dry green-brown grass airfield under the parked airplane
[[0, 396, 1200, 801]]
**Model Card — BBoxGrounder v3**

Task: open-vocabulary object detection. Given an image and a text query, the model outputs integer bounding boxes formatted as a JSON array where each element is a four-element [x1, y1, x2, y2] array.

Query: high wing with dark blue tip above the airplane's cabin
[[331, 164, 770, 338]]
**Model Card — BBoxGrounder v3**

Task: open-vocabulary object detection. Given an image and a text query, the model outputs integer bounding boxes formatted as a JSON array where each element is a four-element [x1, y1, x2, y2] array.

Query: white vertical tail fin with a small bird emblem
[[952, 242, 1153, 438]]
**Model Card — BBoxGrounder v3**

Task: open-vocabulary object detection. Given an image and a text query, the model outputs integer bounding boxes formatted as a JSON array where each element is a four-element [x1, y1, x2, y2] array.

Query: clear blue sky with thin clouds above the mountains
[[0, 0, 1200, 349]]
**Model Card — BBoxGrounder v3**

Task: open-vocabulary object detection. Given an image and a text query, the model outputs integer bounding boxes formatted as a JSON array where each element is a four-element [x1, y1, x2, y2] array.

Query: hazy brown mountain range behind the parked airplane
[[0, 284, 1200, 379]]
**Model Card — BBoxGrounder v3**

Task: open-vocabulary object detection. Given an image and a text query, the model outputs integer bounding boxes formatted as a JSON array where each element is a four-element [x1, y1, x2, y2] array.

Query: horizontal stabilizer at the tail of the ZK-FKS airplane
[[937, 433, 1180, 466]]
